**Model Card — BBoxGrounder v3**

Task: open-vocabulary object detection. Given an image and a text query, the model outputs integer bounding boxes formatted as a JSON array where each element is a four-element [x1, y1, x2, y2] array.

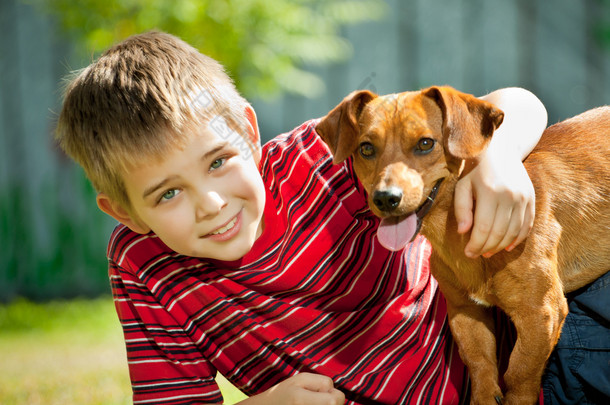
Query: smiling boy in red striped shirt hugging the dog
[[58, 32, 546, 404]]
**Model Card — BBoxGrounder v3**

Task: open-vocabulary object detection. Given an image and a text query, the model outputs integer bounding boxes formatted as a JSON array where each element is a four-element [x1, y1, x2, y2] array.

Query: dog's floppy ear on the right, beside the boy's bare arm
[[423, 86, 504, 159]]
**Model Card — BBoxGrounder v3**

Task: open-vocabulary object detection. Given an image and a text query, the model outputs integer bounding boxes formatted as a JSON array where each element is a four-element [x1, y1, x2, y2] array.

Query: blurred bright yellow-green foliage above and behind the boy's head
[[24, 0, 386, 97]]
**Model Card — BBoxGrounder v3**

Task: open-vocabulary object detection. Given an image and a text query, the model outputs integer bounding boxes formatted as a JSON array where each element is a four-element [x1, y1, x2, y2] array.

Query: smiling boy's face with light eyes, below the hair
[[98, 108, 265, 260]]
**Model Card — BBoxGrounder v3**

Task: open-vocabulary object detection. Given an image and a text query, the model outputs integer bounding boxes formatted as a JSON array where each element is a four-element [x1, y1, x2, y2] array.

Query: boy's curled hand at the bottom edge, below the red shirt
[[240, 373, 345, 405]]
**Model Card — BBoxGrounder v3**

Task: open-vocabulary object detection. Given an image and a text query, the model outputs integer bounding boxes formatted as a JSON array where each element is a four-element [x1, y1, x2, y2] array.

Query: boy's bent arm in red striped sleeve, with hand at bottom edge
[[109, 252, 345, 405]]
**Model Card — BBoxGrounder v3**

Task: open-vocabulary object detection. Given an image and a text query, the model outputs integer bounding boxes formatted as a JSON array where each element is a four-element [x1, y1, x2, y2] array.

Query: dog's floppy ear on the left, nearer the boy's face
[[316, 90, 377, 163]]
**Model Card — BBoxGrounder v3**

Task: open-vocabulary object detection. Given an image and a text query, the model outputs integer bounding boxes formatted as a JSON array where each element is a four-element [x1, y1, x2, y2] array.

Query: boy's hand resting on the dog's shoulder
[[455, 155, 535, 258]]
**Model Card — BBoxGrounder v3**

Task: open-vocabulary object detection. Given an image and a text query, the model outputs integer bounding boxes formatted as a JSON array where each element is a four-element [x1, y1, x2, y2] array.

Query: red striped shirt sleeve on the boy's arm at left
[[109, 261, 223, 405]]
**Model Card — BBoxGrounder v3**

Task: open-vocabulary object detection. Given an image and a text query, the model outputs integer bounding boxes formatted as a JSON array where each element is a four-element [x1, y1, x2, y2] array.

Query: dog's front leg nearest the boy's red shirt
[[431, 254, 502, 405]]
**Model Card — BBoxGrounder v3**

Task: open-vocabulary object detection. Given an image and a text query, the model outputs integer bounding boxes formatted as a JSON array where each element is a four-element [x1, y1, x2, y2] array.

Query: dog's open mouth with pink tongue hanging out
[[377, 178, 443, 252]]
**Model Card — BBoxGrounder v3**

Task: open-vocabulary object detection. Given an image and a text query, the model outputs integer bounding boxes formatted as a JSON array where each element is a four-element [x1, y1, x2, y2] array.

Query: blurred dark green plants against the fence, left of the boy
[[0, 166, 114, 300]]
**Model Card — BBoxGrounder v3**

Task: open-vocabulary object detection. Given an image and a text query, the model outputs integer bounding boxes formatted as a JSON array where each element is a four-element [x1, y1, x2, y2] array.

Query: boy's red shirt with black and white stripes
[[108, 122, 467, 405]]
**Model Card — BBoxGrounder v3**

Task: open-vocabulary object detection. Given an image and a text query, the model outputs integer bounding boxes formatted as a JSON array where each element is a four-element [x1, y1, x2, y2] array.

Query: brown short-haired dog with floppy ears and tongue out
[[316, 87, 610, 405]]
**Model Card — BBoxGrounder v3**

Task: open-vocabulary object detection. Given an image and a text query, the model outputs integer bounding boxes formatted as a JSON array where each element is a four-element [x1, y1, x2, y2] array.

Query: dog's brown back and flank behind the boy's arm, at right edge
[[525, 106, 610, 291]]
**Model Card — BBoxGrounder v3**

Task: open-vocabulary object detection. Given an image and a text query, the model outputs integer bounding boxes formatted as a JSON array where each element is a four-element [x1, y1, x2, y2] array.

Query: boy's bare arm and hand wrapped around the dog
[[455, 88, 547, 257]]
